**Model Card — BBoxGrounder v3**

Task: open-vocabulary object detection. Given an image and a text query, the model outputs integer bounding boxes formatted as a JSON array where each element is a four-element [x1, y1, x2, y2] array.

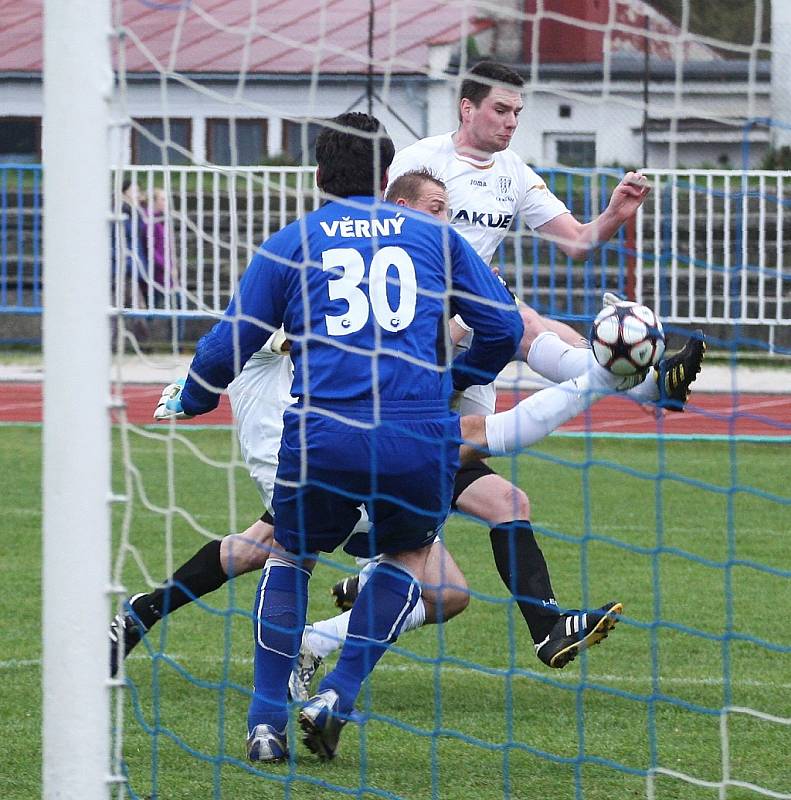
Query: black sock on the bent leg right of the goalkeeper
[[489, 520, 560, 643]]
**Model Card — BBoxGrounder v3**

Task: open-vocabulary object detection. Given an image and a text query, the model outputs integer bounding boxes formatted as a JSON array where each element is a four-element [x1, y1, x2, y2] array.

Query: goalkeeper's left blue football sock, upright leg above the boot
[[247, 558, 310, 730]]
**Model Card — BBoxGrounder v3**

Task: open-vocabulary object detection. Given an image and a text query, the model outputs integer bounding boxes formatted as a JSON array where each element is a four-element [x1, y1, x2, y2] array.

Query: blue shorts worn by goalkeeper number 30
[[272, 401, 461, 558]]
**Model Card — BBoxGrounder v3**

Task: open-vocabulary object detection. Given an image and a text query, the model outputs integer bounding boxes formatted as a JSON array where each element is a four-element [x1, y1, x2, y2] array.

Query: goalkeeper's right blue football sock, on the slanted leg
[[319, 562, 420, 714]]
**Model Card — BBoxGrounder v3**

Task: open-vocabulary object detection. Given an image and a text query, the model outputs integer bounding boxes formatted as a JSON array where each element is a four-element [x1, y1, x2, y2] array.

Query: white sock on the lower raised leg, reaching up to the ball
[[485, 363, 623, 456]]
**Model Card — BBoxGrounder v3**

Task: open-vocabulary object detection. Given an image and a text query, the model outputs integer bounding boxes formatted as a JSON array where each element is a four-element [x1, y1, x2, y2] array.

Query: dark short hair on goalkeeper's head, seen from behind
[[316, 111, 395, 197]]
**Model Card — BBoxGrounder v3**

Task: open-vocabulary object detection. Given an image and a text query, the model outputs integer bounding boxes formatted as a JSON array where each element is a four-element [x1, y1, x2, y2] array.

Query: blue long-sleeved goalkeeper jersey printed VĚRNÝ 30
[[182, 197, 522, 414]]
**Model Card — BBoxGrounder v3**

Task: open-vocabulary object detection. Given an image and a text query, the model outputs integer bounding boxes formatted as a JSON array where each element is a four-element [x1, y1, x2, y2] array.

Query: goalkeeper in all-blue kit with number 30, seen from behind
[[164, 114, 523, 761]]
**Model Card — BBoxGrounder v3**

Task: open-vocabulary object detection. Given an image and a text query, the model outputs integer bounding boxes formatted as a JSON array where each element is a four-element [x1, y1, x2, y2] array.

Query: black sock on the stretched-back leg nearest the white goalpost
[[132, 539, 228, 629]]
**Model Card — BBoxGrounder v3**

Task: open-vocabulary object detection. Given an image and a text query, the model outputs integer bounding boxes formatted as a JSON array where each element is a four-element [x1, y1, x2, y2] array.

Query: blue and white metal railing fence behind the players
[[0, 164, 791, 337]]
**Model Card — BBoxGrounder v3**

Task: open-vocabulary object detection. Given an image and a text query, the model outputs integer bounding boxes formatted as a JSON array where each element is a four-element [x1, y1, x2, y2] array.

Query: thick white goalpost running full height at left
[[41, 0, 112, 800]]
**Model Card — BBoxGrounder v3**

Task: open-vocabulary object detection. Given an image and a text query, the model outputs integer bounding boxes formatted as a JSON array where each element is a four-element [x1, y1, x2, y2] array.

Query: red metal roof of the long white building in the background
[[0, 0, 490, 73]]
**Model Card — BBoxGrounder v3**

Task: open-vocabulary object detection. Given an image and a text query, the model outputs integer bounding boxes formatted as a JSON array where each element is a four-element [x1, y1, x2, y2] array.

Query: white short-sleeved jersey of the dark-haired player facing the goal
[[390, 133, 569, 263]]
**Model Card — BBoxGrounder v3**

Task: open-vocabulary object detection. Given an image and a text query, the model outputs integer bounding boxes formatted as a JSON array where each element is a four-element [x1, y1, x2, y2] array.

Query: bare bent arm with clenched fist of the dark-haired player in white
[[537, 172, 651, 259]]
